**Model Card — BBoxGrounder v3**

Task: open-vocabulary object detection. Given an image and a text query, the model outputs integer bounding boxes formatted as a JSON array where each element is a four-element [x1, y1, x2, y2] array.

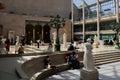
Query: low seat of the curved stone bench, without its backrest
[[30, 62, 83, 80]]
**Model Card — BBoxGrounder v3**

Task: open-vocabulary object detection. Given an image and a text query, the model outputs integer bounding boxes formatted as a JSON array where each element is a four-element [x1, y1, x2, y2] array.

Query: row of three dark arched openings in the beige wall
[[25, 24, 51, 44]]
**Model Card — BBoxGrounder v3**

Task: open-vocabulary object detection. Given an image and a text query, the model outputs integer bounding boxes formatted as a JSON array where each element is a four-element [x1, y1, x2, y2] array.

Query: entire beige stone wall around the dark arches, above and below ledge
[[0, 0, 76, 41]]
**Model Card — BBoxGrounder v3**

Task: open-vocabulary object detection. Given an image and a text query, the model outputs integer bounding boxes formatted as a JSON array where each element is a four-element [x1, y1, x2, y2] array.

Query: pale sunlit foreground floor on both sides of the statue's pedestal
[[47, 62, 120, 80]]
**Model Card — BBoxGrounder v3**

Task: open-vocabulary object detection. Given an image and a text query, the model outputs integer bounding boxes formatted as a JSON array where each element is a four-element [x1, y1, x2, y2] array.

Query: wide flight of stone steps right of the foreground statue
[[93, 52, 120, 66]]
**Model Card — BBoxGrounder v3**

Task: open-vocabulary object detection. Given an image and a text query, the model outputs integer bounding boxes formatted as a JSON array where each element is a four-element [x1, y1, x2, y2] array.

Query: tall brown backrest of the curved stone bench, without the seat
[[22, 51, 84, 77]]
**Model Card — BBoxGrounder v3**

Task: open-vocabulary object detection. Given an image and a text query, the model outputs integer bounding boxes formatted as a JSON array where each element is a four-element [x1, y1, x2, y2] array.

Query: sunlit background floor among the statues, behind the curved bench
[[6, 44, 117, 54]]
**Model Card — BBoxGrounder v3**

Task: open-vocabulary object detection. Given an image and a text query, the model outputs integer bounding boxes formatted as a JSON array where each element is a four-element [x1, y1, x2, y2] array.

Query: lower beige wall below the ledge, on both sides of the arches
[[0, 13, 71, 41]]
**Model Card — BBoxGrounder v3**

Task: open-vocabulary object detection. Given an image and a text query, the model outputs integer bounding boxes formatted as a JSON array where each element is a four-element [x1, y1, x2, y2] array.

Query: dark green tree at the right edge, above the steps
[[110, 22, 120, 48]]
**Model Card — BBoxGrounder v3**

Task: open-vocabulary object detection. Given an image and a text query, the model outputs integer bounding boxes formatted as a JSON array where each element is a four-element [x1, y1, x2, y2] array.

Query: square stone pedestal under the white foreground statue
[[80, 68, 99, 80]]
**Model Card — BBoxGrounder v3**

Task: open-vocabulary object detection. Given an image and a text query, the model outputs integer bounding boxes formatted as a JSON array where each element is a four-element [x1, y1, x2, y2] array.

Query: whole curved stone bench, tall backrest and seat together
[[16, 51, 83, 80]]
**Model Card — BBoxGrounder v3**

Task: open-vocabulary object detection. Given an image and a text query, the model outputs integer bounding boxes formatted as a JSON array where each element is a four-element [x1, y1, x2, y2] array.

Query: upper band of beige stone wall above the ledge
[[1, 0, 71, 18]]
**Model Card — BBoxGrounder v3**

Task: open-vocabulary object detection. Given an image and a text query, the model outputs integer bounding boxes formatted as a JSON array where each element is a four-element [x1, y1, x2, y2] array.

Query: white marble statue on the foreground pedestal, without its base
[[83, 39, 95, 70]]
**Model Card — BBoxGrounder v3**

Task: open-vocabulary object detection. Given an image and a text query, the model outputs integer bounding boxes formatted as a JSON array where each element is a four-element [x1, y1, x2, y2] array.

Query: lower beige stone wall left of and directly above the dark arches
[[0, 13, 50, 37]]
